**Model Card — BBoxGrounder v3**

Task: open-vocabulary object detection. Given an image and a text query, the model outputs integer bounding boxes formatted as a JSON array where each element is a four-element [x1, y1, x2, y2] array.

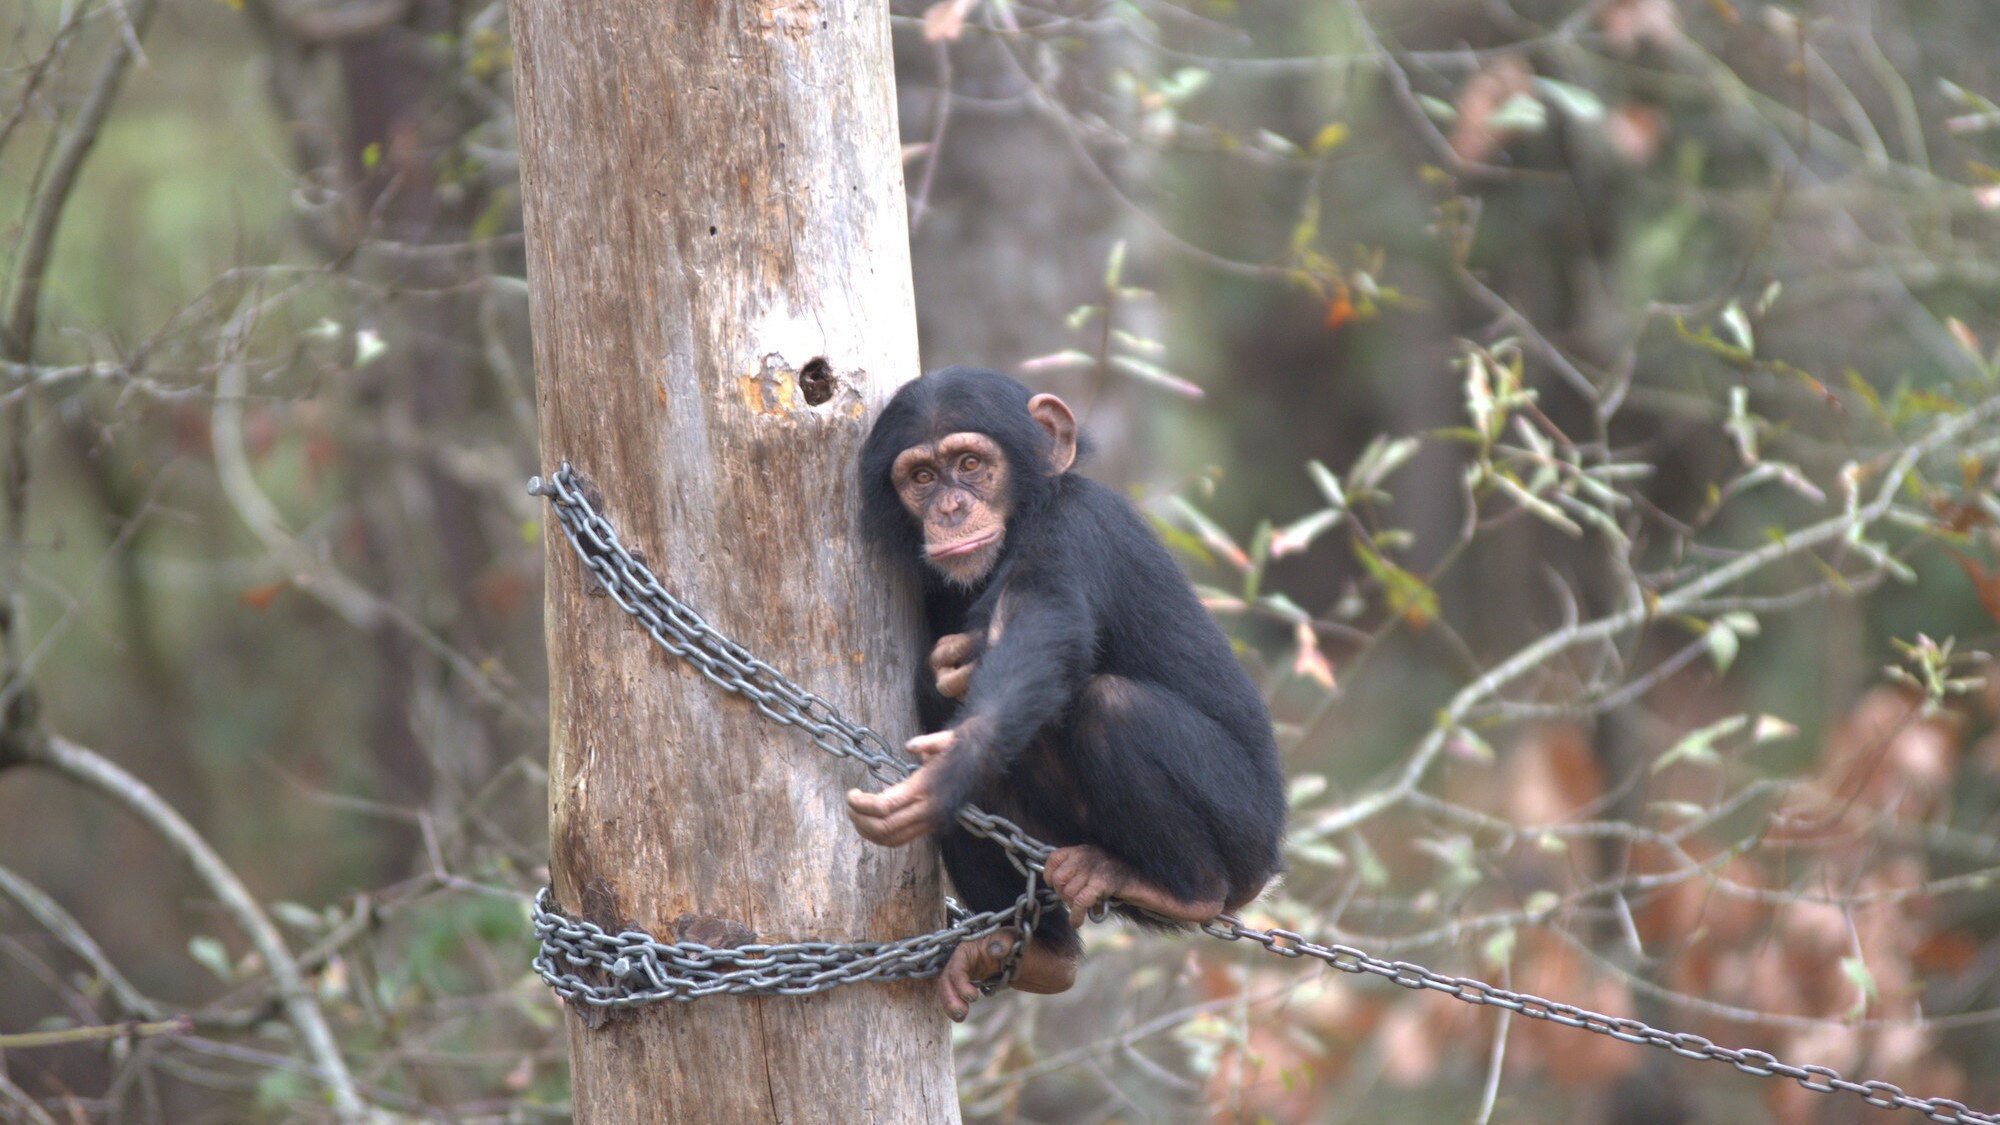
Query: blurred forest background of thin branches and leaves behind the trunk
[[0, 0, 2000, 1125]]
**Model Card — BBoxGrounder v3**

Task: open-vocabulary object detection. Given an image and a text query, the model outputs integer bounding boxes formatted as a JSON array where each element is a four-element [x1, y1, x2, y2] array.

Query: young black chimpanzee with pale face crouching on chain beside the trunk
[[848, 366, 1284, 1019]]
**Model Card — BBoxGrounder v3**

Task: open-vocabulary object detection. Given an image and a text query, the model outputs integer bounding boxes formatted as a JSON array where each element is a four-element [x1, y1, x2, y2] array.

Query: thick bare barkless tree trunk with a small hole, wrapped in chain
[[512, 0, 958, 1125]]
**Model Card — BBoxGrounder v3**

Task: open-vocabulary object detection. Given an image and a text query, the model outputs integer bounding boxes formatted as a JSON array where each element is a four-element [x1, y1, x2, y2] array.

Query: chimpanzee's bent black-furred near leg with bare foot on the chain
[[1048, 675, 1284, 921]]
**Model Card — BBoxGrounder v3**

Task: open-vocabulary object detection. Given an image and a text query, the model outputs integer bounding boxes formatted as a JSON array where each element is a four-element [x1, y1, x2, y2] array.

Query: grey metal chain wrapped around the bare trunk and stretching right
[[528, 462, 2000, 1125]]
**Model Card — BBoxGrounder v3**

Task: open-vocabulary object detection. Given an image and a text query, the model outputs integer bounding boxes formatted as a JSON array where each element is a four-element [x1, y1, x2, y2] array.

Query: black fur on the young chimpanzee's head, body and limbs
[[860, 366, 1284, 949]]
